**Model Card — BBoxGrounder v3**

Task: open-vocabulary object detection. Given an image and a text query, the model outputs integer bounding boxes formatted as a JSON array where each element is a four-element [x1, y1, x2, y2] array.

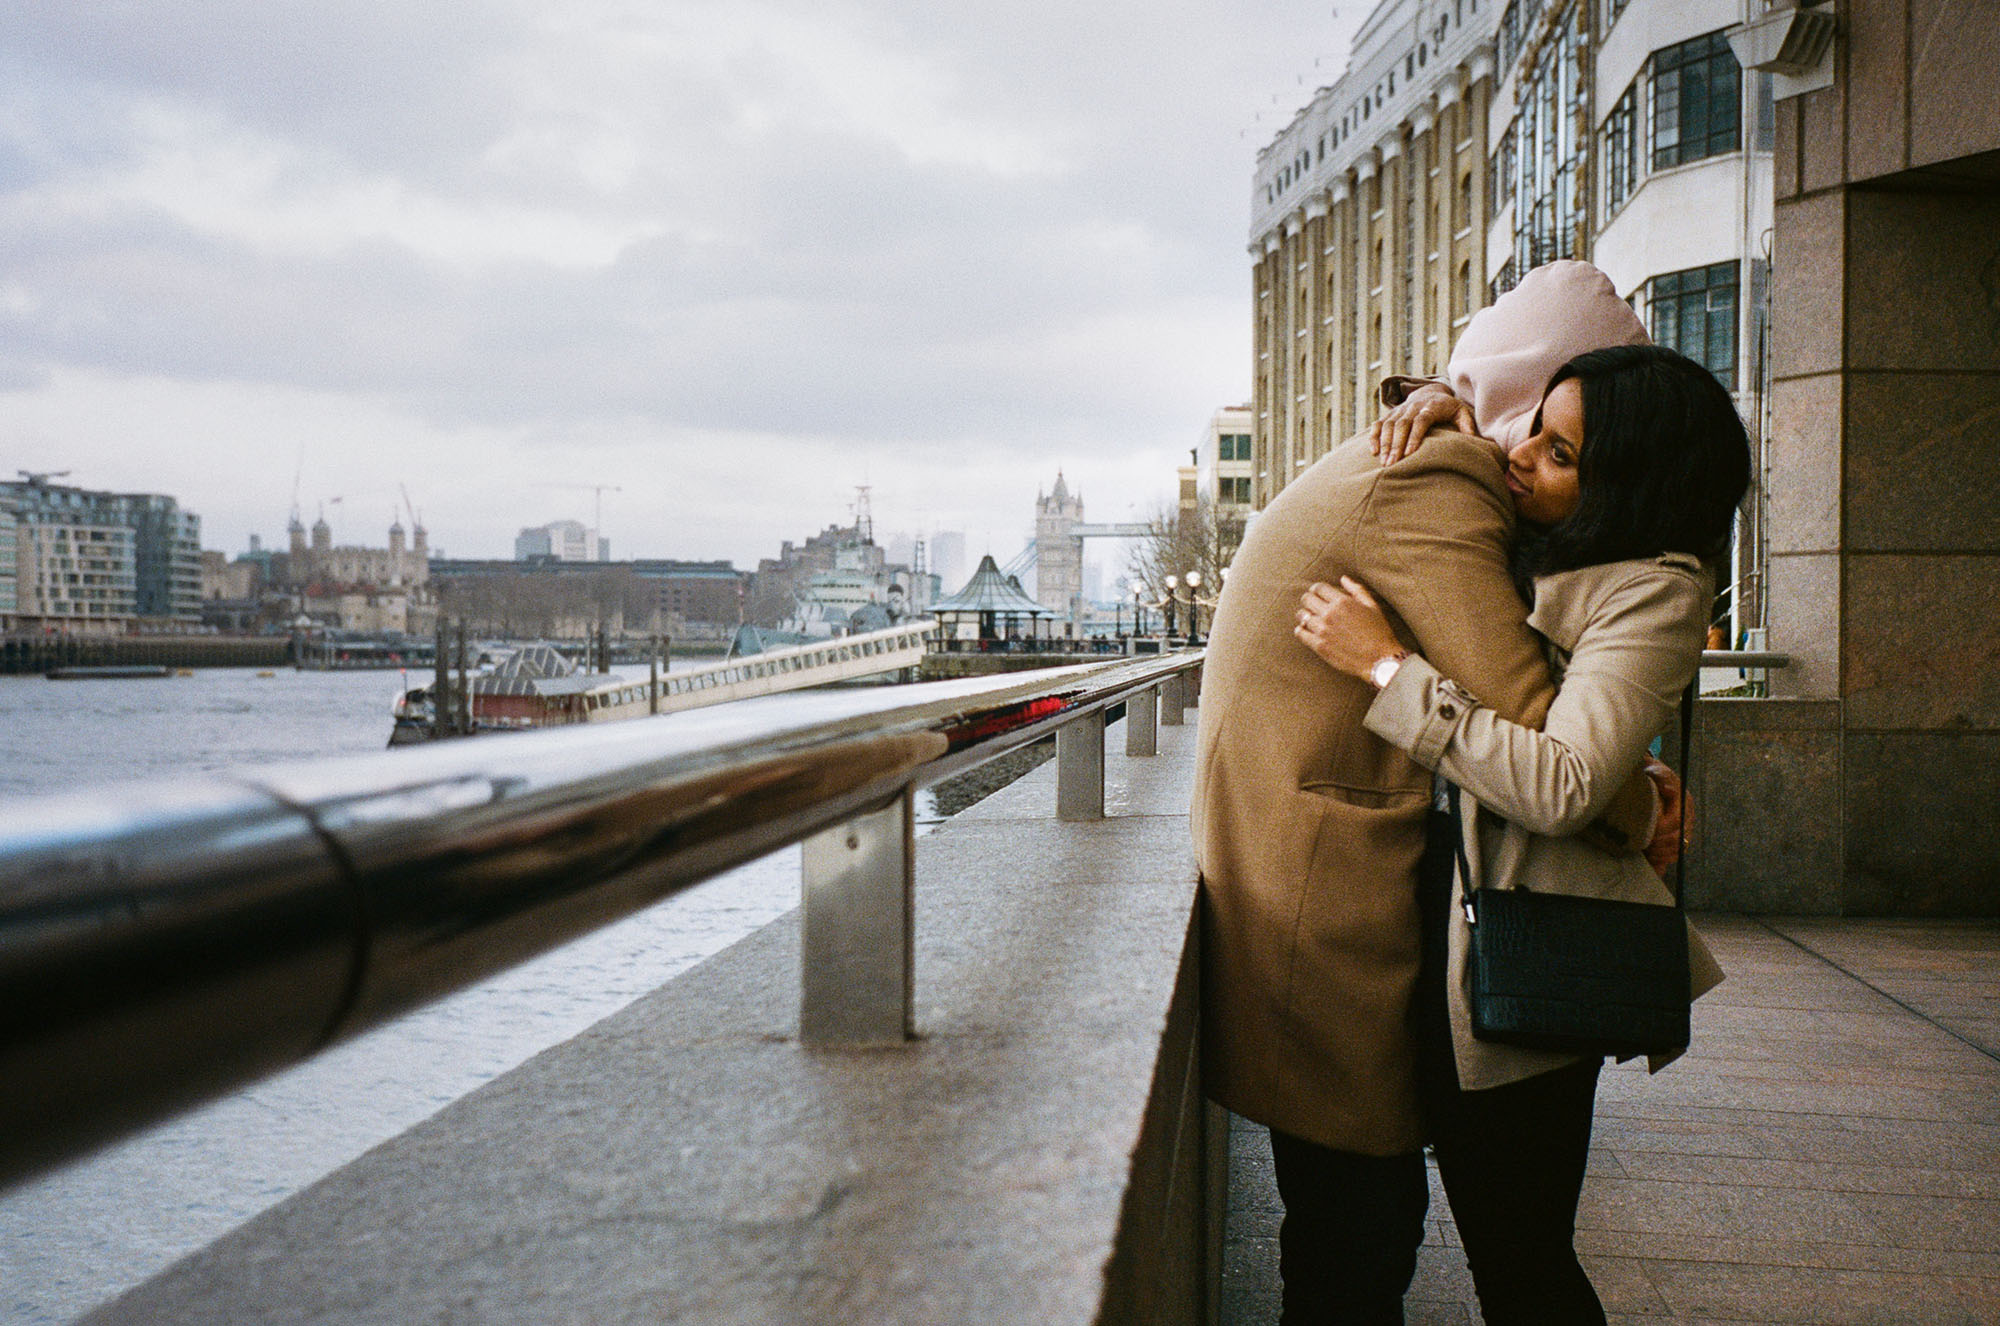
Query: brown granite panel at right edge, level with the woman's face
[[1840, 372, 2000, 552]]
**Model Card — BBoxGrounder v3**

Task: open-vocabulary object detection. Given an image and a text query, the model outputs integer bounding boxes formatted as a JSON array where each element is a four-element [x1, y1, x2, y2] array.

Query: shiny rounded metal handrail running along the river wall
[[0, 652, 1202, 1182]]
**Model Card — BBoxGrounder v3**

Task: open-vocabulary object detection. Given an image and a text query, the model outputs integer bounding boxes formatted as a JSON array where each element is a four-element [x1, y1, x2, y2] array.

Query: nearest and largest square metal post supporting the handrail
[[798, 788, 916, 1046]]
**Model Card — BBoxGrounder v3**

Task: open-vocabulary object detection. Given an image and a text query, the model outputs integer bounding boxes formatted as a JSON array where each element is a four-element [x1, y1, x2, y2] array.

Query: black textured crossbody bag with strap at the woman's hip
[[1450, 684, 1694, 1058]]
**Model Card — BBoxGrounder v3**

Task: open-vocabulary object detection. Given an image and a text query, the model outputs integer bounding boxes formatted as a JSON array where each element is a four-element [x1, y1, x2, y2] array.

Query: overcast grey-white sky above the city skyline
[[0, 0, 1366, 566]]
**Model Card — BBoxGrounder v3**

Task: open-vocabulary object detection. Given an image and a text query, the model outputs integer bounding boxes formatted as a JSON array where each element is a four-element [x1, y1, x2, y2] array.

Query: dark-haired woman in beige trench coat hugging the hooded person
[[1294, 346, 1750, 1326]]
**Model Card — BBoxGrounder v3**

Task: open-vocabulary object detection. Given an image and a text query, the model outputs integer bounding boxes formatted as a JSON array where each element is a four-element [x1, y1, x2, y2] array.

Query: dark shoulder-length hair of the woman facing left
[[1516, 346, 1750, 578]]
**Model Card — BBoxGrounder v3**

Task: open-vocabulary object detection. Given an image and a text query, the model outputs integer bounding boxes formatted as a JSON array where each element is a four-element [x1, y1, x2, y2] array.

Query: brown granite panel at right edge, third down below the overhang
[[1840, 554, 2000, 732]]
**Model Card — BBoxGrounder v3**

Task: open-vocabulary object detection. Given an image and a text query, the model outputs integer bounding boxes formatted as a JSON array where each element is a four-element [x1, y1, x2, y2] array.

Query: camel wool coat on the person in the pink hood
[[1192, 432, 1656, 1156]]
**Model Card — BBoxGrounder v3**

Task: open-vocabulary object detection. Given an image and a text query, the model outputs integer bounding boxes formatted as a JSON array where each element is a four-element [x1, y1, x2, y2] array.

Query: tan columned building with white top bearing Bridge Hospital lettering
[[1250, 0, 1498, 508]]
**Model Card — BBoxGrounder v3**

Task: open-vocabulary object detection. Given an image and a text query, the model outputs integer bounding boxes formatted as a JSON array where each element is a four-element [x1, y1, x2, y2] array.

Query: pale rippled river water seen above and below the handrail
[[0, 668, 852, 1324]]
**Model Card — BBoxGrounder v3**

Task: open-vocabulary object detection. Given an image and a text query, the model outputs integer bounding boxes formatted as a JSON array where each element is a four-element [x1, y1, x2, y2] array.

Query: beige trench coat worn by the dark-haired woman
[[1368, 554, 1722, 1090]]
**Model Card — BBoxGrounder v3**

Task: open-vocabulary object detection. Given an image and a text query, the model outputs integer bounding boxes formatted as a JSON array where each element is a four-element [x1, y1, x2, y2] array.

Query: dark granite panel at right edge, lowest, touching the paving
[[1842, 732, 2000, 916]]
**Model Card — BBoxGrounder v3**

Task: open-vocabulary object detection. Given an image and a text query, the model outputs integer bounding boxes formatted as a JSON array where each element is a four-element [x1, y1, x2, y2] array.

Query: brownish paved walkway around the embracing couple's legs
[[1222, 916, 2000, 1326]]
